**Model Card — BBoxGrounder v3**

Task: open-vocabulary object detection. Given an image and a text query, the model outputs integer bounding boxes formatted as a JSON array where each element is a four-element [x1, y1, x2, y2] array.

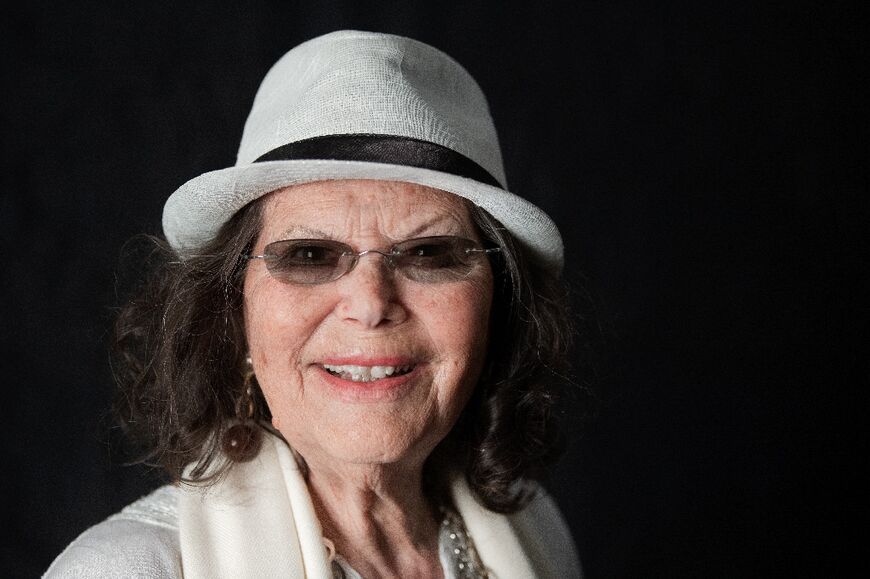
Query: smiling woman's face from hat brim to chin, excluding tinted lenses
[[244, 181, 493, 466]]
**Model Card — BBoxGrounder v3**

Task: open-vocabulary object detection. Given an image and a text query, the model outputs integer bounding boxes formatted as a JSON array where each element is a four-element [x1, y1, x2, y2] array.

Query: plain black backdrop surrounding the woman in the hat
[[0, 0, 870, 578]]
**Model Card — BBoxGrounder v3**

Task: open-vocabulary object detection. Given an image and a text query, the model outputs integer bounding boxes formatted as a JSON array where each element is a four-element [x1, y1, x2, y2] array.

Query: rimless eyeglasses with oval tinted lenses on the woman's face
[[246, 236, 501, 285]]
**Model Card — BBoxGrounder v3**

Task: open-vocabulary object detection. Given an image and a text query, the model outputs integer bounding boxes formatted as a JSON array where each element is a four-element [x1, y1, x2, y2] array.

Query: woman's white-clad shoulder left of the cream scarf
[[43, 486, 181, 579]]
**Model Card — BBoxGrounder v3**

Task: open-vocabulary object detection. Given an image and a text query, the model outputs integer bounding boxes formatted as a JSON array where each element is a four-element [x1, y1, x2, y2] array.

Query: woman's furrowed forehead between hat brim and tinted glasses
[[263, 180, 474, 239]]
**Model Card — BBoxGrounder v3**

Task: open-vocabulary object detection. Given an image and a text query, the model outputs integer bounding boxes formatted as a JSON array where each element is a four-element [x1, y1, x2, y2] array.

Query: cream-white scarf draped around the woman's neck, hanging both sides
[[179, 436, 565, 579]]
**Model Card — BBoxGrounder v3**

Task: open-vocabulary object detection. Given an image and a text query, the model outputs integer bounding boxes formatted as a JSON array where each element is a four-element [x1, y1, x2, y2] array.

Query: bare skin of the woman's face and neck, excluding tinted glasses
[[244, 181, 493, 576]]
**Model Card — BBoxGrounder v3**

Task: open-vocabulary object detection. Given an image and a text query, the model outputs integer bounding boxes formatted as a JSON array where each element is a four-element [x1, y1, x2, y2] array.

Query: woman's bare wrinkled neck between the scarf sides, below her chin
[[308, 462, 441, 577]]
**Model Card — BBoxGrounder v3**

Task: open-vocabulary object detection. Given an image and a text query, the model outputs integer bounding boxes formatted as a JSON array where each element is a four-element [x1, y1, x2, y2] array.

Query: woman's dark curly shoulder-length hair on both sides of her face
[[112, 193, 572, 513]]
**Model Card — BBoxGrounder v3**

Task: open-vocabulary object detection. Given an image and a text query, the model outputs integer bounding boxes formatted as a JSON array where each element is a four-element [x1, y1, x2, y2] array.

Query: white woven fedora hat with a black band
[[163, 31, 563, 272]]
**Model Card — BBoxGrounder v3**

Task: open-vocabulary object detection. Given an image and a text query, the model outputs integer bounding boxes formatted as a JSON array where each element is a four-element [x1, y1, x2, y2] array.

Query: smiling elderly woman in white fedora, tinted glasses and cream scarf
[[46, 31, 580, 579]]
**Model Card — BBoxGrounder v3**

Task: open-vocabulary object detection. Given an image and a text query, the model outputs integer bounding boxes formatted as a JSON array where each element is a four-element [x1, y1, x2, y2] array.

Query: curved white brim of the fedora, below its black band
[[163, 159, 563, 273]]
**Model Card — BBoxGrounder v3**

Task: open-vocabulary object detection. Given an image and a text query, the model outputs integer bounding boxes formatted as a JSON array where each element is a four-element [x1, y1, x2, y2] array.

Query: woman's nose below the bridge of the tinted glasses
[[338, 252, 408, 328]]
